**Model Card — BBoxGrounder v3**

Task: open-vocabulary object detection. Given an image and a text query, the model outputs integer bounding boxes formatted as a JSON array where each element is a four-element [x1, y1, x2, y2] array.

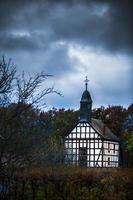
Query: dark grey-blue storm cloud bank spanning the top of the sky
[[0, 0, 133, 53]]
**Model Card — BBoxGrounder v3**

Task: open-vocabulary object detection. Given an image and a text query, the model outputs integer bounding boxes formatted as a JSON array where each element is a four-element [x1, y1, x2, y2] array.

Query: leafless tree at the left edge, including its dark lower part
[[0, 57, 61, 173]]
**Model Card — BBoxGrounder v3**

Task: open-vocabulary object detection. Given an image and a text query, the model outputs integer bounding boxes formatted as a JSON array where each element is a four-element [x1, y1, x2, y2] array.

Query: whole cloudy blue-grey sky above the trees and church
[[0, 0, 133, 109]]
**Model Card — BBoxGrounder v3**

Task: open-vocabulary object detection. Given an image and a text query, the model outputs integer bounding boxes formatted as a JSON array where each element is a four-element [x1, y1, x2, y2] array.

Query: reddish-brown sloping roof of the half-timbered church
[[91, 118, 120, 142]]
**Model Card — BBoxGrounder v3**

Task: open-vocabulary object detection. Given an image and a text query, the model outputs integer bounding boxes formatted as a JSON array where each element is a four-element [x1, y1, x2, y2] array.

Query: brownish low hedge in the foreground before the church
[[4, 167, 133, 200]]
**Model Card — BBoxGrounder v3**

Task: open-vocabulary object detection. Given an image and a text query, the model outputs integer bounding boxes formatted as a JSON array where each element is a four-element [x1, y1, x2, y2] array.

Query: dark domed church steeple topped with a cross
[[80, 76, 92, 122]]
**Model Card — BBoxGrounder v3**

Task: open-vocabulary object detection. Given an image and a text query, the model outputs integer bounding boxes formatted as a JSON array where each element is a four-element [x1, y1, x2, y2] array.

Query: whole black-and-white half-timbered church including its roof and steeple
[[64, 78, 119, 167]]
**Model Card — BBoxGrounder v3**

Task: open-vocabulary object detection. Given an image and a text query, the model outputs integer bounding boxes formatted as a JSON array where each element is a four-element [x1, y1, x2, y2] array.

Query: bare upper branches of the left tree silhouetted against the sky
[[0, 57, 61, 106]]
